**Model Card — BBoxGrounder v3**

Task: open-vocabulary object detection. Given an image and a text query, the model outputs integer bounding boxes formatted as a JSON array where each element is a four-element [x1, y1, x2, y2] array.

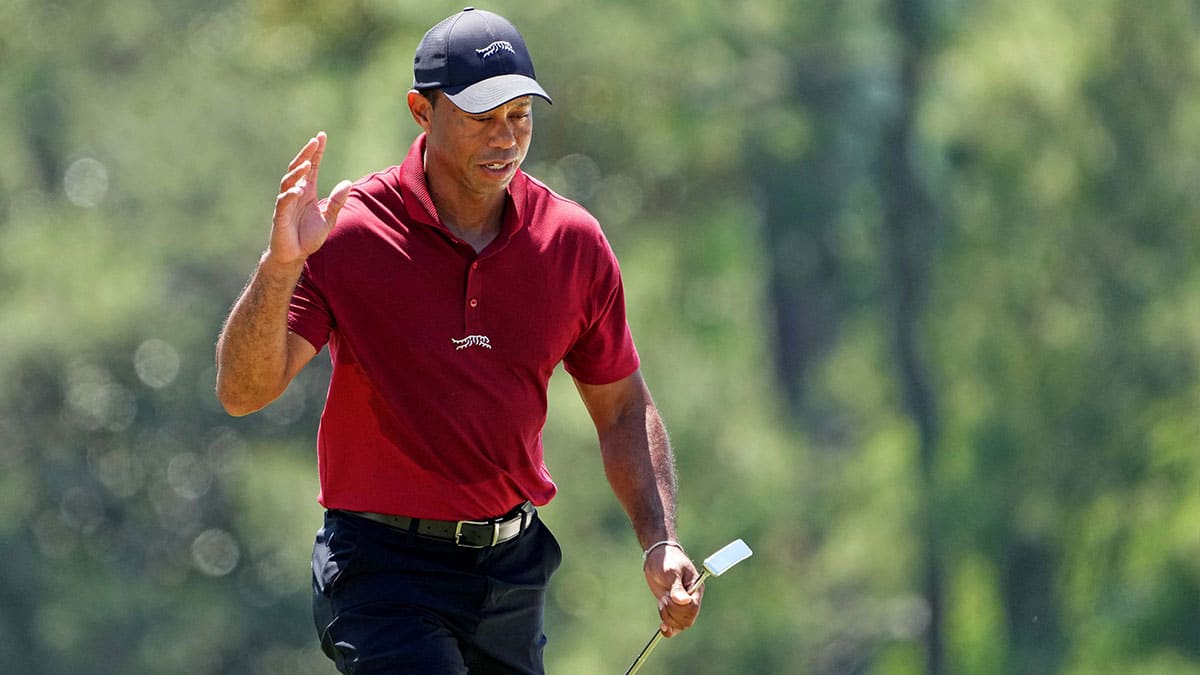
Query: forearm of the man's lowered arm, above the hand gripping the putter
[[600, 395, 676, 549]]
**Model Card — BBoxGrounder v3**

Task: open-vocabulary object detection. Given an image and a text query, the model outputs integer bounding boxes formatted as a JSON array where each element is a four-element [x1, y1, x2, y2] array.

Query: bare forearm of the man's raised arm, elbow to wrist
[[216, 256, 304, 416]]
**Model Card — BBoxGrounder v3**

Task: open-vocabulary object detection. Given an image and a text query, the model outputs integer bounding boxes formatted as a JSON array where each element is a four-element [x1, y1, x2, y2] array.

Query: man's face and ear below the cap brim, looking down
[[414, 91, 533, 197]]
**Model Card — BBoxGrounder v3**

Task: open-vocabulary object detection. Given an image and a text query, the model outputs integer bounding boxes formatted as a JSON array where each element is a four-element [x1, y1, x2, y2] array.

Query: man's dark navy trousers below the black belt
[[312, 509, 563, 675]]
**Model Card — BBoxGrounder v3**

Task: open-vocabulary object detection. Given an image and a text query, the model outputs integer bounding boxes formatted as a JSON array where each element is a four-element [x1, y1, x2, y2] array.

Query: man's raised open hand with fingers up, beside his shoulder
[[265, 131, 350, 264]]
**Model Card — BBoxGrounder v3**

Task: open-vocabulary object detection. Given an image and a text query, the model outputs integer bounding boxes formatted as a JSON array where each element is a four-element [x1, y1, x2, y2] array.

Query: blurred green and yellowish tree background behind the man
[[0, 0, 1200, 675]]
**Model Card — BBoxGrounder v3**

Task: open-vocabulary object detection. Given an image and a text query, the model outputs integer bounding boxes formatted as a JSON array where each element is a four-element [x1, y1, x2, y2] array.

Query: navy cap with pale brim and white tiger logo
[[413, 7, 553, 114]]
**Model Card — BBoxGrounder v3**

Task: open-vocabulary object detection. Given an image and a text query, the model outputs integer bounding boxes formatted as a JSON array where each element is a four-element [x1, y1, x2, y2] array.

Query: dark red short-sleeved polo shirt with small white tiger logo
[[288, 136, 638, 520]]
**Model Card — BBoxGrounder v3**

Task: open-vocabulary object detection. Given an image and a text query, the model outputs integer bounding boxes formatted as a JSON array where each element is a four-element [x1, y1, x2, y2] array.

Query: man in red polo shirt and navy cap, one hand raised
[[217, 8, 700, 673]]
